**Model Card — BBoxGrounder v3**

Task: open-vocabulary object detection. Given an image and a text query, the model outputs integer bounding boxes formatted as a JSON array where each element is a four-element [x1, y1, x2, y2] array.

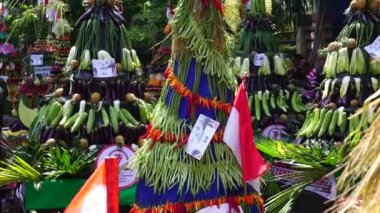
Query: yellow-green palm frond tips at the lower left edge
[[0, 156, 41, 186]]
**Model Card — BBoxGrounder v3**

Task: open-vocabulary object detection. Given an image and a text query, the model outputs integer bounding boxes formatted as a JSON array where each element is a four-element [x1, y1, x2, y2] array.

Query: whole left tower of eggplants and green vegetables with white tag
[[26, 1, 153, 147]]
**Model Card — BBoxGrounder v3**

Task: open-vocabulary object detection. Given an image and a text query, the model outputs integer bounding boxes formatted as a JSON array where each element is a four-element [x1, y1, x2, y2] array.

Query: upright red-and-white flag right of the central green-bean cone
[[223, 82, 268, 192]]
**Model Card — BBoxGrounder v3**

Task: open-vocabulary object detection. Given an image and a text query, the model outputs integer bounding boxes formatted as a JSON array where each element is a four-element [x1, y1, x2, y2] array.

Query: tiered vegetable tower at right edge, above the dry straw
[[298, 0, 380, 145]]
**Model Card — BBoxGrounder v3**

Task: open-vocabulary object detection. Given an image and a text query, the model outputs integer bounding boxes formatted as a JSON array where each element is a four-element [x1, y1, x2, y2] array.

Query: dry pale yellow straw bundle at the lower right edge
[[330, 90, 380, 213]]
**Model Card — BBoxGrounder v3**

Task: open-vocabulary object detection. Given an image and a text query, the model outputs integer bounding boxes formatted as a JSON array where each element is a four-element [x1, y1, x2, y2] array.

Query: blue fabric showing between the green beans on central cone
[[136, 59, 260, 213]]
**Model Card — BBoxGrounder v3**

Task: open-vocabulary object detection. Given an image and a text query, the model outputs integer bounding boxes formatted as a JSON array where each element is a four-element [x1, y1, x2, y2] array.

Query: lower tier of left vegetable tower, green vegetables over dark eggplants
[[30, 91, 153, 145]]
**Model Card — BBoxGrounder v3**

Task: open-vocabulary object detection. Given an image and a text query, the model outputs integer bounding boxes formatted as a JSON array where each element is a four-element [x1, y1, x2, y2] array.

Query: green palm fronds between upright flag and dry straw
[[255, 136, 342, 213]]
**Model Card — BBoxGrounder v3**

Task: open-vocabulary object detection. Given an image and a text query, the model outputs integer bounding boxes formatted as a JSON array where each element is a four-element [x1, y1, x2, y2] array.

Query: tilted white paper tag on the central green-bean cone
[[186, 114, 219, 160]]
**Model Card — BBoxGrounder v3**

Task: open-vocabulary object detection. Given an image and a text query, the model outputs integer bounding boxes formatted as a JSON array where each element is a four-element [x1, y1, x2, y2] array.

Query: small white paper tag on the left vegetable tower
[[92, 58, 117, 78]]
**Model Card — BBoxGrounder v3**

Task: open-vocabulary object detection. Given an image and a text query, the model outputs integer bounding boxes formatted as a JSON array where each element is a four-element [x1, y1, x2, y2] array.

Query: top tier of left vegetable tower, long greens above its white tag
[[65, 0, 141, 74]]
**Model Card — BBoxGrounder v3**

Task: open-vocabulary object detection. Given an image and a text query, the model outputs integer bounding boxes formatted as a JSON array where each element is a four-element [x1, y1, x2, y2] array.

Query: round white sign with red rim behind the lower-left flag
[[96, 145, 137, 189]]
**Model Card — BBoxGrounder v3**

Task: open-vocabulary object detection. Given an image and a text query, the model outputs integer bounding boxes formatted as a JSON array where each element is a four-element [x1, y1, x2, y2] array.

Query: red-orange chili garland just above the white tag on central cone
[[165, 66, 232, 114]]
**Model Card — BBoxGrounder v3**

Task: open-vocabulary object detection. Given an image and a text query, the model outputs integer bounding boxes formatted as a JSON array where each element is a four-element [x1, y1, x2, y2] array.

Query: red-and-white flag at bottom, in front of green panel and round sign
[[64, 158, 119, 213]]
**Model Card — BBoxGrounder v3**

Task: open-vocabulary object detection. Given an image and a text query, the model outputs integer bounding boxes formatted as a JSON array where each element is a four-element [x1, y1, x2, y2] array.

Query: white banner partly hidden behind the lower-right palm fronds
[[271, 162, 337, 200]]
